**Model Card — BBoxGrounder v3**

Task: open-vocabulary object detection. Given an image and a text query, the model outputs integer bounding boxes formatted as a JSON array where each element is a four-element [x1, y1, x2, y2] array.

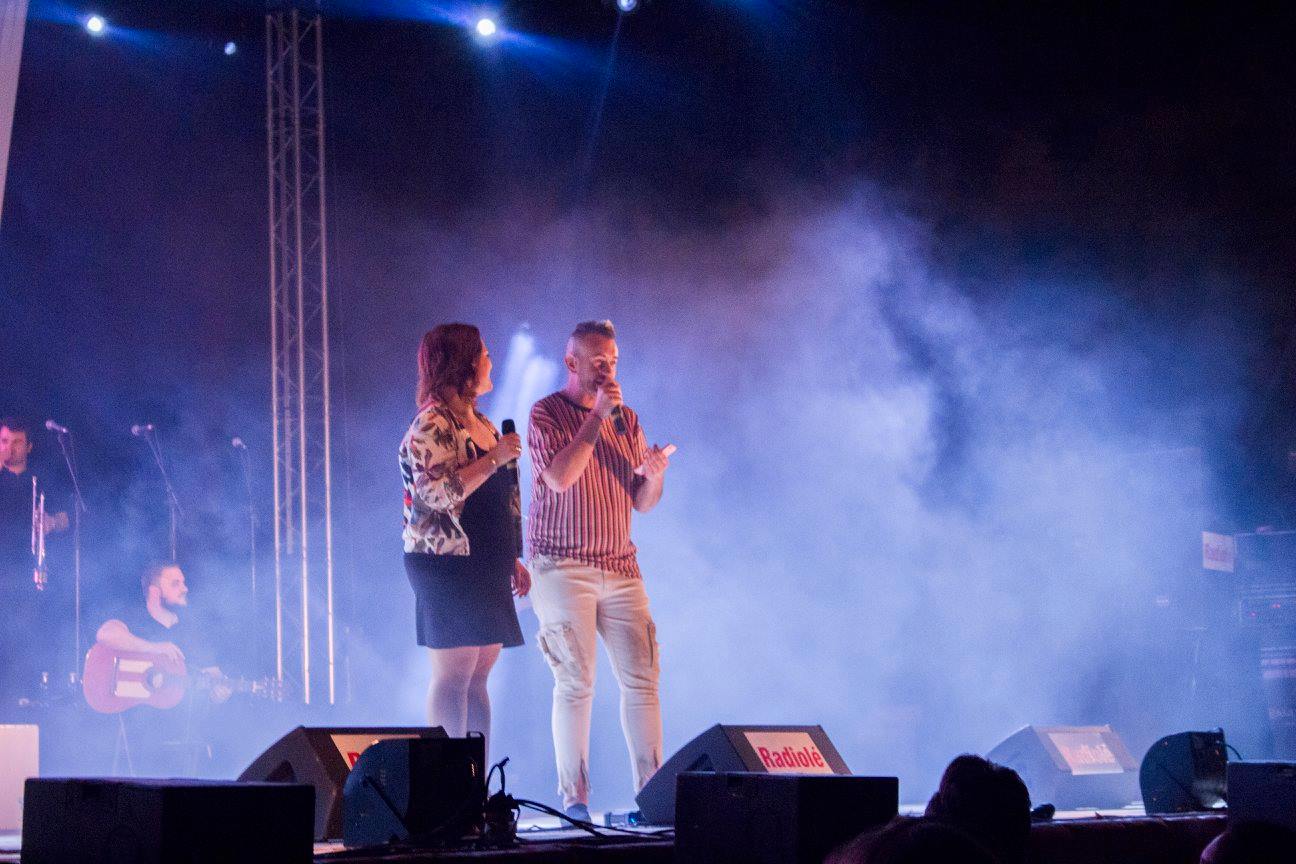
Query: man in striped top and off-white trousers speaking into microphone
[[527, 321, 669, 820]]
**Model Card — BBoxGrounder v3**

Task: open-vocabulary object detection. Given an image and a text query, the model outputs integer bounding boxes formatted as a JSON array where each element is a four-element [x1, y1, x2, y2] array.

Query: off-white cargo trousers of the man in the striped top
[[529, 556, 662, 807]]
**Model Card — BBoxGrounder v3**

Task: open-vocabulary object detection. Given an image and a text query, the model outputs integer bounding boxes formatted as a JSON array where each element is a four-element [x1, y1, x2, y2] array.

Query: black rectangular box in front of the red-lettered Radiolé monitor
[[675, 772, 899, 864]]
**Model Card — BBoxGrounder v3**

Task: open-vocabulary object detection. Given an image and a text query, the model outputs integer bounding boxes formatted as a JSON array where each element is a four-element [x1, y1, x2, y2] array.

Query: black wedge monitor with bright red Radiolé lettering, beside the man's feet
[[635, 724, 850, 825]]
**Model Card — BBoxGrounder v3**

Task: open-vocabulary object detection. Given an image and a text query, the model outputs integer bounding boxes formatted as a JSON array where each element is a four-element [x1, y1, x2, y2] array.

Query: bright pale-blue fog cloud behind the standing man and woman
[[318, 185, 1259, 804]]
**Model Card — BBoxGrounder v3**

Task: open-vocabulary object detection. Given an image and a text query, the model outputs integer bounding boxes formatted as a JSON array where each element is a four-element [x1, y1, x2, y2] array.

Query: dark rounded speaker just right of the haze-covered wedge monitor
[[1138, 729, 1229, 813]]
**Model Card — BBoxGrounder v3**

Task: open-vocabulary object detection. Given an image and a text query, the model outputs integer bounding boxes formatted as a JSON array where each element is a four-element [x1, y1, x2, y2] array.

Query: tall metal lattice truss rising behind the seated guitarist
[[266, 3, 337, 705]]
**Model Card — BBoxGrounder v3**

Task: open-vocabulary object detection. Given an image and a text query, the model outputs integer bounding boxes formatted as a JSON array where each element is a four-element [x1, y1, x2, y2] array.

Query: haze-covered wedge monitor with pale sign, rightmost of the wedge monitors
[[986, 725, 1139, 810]]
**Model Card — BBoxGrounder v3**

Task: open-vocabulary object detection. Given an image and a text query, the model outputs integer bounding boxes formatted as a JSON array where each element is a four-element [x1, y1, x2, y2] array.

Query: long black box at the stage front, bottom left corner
[[22, 777, 315, 864]]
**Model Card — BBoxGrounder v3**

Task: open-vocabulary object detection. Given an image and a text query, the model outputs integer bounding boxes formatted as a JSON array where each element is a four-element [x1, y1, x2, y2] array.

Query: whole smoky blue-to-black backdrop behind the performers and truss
[[0, 0, 1296, 803]]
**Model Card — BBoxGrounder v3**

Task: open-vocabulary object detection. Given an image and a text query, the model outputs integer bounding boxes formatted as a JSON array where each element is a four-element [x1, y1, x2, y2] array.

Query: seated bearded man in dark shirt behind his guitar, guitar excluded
[[96, 563, 231, 776]]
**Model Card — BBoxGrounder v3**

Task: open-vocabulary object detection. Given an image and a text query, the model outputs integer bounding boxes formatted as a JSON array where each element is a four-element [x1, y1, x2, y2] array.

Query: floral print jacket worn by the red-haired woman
[[399, 403, 521, 554]]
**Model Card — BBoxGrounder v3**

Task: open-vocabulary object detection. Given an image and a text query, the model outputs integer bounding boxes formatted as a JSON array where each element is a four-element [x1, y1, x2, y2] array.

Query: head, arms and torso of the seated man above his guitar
[[96, 563, 231, 703]]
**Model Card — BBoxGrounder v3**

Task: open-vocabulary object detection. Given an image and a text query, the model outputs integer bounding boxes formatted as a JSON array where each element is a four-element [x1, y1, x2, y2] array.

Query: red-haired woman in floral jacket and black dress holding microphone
[[399, 324, 531, 751]]
